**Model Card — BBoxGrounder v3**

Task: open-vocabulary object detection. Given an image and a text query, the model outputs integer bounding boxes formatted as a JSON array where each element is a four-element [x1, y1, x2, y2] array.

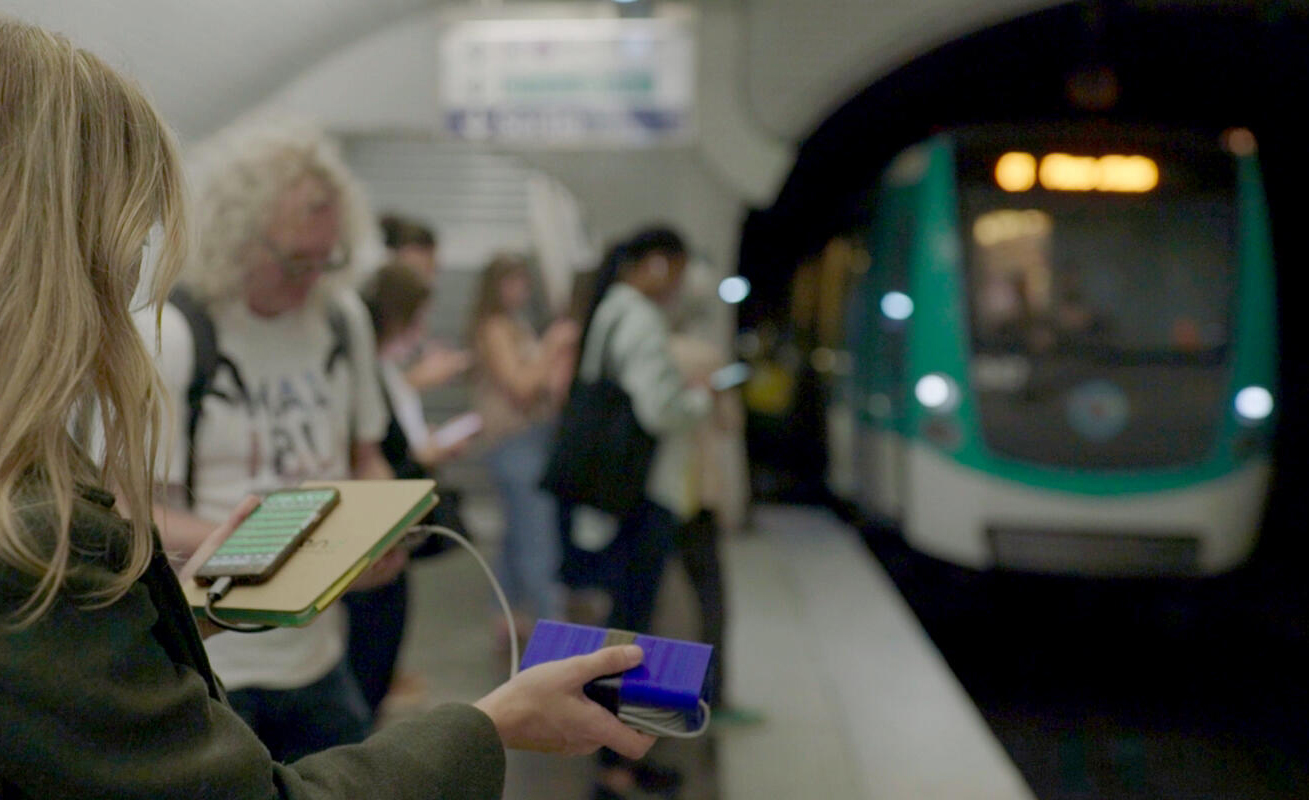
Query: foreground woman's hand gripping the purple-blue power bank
[[474, 644, 655, 758]]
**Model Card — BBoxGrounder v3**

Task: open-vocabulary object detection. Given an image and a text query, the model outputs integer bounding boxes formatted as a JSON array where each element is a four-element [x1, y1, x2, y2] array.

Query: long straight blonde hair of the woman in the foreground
[[0, 17, 186, 627]]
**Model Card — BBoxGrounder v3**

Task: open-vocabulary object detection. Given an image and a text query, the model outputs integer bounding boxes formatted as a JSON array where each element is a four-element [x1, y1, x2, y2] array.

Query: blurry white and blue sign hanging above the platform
[[437, 16, 695, 147]]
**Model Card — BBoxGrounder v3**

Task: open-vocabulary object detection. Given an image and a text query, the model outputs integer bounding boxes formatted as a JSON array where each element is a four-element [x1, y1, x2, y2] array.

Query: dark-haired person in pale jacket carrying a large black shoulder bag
[[560, 227, 713, 800]]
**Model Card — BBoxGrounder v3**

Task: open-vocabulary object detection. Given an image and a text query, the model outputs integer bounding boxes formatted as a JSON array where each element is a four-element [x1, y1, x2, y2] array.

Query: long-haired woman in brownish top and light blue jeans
[[469, 254, 577, 644]]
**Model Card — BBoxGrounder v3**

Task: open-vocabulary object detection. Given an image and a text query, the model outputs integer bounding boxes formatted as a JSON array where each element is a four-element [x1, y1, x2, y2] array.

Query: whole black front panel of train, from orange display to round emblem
[[957, 130, 1238, 470]]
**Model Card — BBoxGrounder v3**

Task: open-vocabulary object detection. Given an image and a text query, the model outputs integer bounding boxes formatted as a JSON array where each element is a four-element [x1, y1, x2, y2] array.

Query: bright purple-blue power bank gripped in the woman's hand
[[522, 619, 713, 729]]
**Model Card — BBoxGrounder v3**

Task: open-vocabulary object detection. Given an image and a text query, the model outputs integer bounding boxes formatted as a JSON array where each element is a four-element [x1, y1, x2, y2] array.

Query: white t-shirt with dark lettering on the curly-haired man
[[145, 291, 387, 690]]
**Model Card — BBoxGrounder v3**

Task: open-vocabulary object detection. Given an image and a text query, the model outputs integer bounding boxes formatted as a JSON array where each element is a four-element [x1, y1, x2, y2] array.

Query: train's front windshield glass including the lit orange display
[[959, 138, 1236, 361]]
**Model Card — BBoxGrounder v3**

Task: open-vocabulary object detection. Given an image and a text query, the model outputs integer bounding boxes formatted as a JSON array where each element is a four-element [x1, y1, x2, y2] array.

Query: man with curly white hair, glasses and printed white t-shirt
[[147, 120, 398, 761]]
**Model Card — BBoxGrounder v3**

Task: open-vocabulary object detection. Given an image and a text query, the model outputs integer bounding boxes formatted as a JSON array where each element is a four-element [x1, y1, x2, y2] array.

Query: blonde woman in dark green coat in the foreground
[[0, 17, 652, 800]]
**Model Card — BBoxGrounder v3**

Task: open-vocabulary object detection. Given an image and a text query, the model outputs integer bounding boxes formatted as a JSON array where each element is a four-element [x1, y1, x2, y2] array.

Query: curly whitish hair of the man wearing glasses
[[182, 115, 378, 304]]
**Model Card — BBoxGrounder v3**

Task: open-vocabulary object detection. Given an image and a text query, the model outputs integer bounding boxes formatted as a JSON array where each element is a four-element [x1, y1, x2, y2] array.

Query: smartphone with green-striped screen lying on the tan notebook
[[195, 488, 340, 585]]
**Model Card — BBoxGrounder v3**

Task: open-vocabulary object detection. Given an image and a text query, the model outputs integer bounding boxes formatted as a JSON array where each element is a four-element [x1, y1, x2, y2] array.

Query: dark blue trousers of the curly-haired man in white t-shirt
[[264, 659, 372, 762]]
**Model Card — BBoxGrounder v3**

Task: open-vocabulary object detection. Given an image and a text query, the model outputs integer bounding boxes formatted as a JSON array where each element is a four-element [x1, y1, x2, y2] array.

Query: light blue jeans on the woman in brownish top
[[487, 424, 563, 619]]
